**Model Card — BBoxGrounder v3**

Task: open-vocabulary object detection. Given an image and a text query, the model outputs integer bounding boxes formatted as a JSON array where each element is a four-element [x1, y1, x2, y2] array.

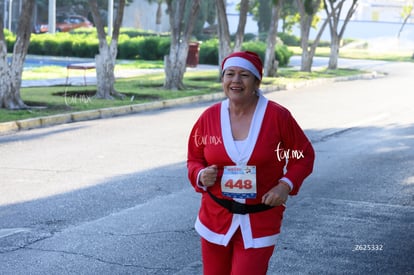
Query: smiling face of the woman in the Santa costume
[[222, 66, 260, 103]]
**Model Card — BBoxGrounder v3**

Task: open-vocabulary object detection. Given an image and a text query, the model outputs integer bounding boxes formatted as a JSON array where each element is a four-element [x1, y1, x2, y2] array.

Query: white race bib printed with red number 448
[[221, 165, 257, 199]]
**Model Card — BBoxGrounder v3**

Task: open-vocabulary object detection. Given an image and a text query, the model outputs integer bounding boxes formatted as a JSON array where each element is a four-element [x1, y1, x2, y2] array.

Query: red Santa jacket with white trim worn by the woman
[[187, 94, 315, 248]]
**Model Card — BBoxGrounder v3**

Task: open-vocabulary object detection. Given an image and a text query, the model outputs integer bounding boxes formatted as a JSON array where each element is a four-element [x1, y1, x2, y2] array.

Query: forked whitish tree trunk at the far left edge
[[0, 0, 35, 110]]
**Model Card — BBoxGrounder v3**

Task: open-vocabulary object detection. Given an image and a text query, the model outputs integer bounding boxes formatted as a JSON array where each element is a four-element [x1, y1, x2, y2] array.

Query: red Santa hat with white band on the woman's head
[[221, 51, 263, 80]]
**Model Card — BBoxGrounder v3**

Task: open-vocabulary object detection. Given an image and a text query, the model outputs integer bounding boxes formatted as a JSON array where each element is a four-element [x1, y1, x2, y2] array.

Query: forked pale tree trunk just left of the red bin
[[164, 0, 201, 90]]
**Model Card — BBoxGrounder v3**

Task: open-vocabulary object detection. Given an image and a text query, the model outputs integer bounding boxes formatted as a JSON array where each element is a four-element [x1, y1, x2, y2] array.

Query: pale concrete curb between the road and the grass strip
[[0, 72, 384, 135]]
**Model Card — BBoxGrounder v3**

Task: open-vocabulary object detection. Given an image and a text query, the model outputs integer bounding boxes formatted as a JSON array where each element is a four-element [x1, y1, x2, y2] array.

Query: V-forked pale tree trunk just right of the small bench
[[88, 0, 125, 99]]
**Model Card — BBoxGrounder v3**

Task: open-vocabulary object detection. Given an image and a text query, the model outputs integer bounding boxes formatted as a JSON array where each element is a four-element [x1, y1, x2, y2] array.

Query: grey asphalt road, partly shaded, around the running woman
[[0, 62, 414, 274]]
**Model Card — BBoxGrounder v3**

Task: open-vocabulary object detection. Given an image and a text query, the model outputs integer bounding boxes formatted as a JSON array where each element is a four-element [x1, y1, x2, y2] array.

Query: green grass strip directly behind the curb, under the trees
[[0, 66, 360, 122]]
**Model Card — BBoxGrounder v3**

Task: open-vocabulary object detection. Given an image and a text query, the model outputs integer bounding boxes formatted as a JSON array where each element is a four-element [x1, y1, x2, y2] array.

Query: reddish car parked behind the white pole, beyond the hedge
[[34, 15, 93, 33]]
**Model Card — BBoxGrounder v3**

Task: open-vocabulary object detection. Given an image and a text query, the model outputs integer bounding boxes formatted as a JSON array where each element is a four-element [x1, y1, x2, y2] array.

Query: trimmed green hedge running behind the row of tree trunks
[[5, 29, 292, 66]]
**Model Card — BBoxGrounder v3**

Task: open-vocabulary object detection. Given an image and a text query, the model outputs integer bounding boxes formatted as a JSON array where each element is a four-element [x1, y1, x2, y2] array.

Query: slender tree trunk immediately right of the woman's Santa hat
[[264, 0, 283, 77]]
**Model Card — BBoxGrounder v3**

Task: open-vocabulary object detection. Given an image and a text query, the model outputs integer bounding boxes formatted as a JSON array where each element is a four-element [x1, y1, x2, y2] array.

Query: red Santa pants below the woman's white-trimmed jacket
[[201, 230, 275, 275]]
